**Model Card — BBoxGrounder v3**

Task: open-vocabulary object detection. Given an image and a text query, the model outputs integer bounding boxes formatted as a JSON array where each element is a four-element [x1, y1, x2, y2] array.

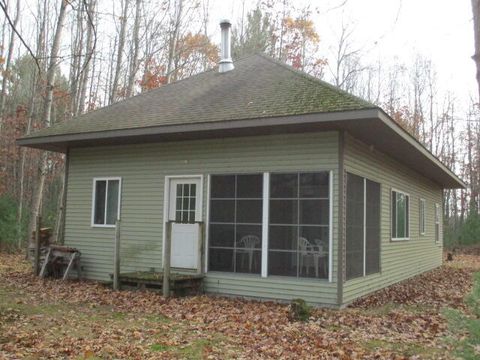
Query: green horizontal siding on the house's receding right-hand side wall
[[343, 136, 443, 303]]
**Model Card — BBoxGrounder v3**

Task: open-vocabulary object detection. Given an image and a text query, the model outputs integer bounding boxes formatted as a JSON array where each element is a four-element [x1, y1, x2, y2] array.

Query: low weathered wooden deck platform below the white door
[[114, 271, 205, 296]]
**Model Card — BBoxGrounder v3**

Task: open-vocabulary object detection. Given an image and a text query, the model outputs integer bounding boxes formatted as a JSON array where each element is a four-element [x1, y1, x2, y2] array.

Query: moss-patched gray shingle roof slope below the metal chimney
[[24, 54, 376, 137]]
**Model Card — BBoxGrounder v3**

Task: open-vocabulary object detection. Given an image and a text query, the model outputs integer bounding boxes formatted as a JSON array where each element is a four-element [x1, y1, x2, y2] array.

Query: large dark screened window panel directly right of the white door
[[208, 174, 263, 274]]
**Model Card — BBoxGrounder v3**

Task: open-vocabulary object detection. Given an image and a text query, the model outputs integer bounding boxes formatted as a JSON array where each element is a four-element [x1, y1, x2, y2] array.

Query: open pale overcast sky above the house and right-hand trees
[[211, 0, 477, 109]]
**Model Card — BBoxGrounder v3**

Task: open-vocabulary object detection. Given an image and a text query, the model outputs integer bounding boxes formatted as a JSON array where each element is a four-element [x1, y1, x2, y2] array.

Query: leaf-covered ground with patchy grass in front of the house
[[0, 249, 480, 359]]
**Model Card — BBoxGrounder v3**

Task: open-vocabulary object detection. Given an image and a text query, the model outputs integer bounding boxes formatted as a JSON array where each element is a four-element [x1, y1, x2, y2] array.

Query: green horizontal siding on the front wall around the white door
[[65, 132, 338, 305]]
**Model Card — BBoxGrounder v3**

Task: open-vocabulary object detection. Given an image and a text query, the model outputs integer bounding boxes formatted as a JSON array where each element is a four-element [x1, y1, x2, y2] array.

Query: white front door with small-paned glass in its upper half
[[168, 177, 202, 269]]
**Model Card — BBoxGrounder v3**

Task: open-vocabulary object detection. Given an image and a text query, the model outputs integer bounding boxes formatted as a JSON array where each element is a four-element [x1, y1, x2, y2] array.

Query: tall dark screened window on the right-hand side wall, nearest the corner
[[345, 173, 380, 280]]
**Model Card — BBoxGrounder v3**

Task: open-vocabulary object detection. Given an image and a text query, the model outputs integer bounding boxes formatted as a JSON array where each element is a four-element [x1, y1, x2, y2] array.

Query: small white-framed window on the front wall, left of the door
[[92, 178, 120, 227]]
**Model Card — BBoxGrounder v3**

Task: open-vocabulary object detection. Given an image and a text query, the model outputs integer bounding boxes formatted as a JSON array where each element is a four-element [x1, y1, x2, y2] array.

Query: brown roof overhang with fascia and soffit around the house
[[17, 108, 465, 188]]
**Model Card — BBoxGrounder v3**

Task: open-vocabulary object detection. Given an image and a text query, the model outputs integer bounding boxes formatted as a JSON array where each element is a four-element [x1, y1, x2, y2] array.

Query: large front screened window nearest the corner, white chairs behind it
[[268, 171, 330, 278]]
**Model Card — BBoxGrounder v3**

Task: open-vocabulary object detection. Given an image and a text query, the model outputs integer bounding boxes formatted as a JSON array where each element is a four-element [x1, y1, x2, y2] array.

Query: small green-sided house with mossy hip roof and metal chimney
[[18, 23, 464, 307]]
